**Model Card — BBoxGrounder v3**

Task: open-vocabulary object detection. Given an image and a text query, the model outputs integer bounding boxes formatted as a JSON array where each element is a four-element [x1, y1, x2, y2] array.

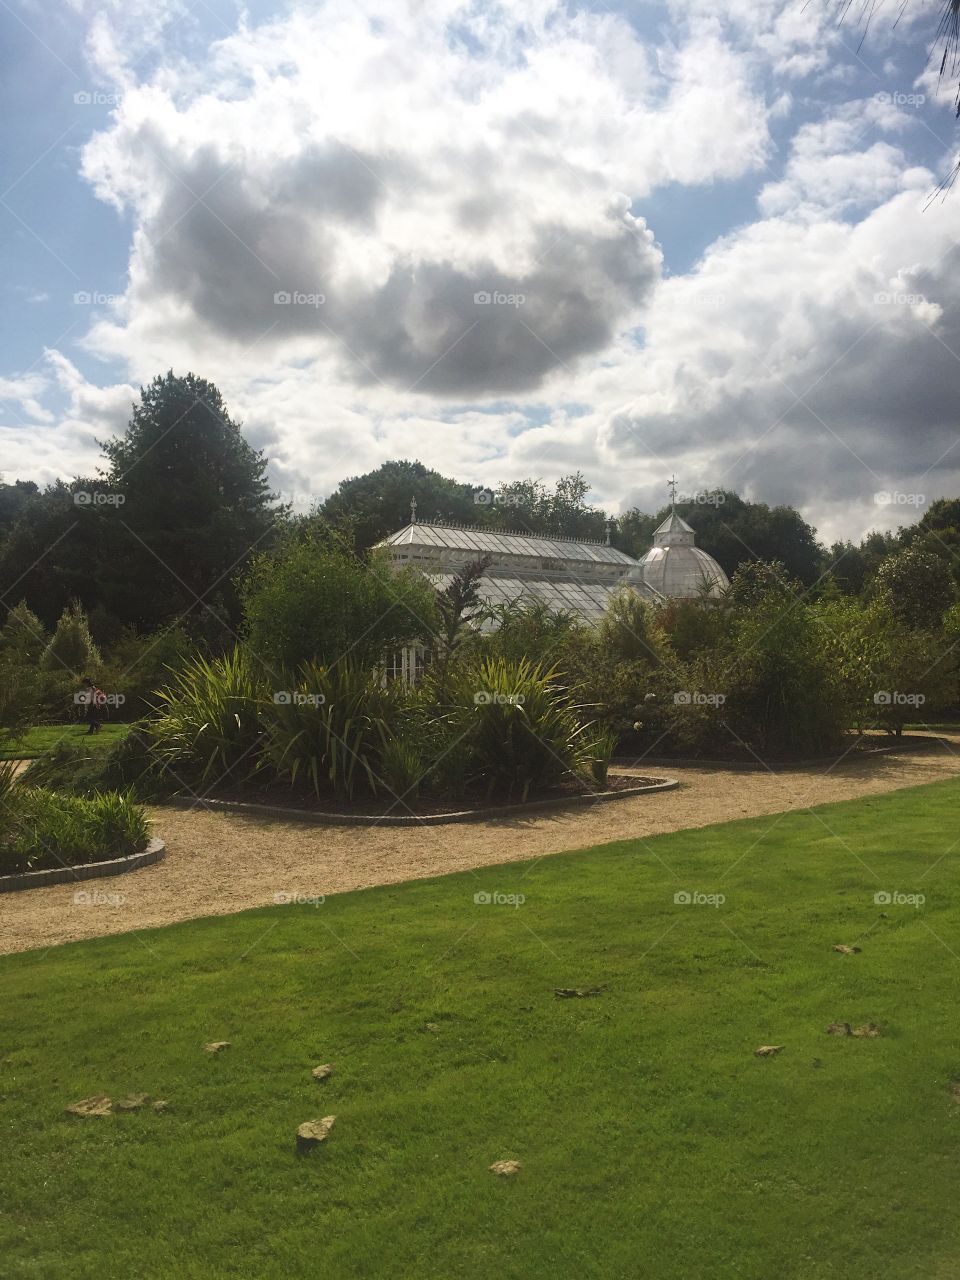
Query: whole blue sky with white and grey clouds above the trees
[[0, 0, 960, 540]]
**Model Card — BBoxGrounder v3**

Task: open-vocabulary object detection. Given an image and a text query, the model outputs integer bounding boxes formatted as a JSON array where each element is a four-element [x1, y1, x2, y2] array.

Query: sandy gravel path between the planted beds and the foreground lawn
[[0, 736, 960, 954]]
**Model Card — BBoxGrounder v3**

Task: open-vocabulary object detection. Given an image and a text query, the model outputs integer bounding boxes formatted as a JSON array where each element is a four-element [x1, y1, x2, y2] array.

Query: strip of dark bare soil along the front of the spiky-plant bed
[[165, 773, 680, 827]]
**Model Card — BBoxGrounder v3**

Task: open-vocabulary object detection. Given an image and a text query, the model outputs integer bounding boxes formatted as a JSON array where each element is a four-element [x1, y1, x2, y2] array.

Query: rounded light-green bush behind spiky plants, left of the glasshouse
[[242, 525, 436, 687]]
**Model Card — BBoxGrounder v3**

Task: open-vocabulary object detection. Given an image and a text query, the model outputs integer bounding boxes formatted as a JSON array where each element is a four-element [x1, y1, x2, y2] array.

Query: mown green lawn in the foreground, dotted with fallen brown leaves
[[0, 782, 960, 1280]]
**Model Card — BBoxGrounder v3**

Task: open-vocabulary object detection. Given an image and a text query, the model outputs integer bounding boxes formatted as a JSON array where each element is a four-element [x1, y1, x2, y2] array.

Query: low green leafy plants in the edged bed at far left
[[0, 785, 150, 876]]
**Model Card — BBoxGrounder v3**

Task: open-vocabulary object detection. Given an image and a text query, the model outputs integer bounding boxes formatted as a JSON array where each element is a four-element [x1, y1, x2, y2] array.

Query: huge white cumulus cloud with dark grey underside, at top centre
[[75, 3, 769, 398]]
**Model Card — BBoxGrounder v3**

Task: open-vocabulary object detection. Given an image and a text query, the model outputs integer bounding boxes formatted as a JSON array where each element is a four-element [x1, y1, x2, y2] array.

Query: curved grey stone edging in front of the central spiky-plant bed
[[164, 778, 680, 827]]
